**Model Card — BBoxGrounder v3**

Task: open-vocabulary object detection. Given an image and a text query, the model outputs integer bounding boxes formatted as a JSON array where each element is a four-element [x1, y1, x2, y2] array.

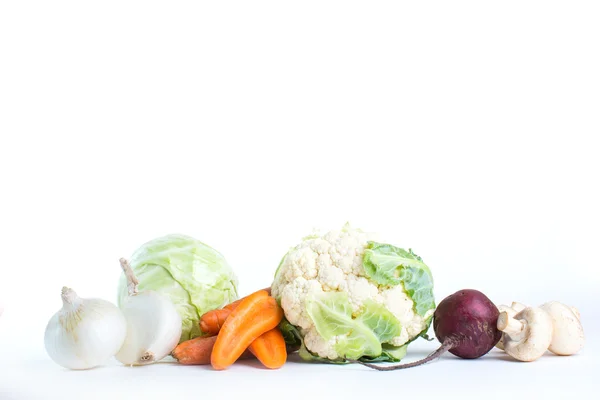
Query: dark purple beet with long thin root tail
[[360, 289, 502, 371]]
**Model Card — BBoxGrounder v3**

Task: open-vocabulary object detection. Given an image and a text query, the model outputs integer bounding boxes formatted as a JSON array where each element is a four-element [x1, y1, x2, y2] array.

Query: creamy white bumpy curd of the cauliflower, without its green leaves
[[271, 226, 433, 359]]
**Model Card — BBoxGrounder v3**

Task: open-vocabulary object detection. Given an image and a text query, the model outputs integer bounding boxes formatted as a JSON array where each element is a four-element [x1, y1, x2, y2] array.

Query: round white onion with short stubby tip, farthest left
[[44, 287, 126, 369]]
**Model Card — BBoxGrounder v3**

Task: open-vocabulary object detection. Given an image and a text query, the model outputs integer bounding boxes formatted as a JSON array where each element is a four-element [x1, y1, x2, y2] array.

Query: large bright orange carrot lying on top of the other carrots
[[210, 290, 283, 370]]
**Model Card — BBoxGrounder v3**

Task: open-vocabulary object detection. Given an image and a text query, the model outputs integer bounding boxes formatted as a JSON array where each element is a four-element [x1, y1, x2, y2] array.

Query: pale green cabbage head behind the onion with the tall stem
[[118, 235, 238, 341]]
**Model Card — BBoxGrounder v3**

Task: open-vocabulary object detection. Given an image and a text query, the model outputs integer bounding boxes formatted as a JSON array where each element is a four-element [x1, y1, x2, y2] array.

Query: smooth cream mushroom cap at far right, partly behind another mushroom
[[540, 301, 585, 356]]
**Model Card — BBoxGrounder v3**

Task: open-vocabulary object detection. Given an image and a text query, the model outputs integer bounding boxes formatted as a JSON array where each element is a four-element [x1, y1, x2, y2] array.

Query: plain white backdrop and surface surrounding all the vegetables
[[0, 1, 600, 400]]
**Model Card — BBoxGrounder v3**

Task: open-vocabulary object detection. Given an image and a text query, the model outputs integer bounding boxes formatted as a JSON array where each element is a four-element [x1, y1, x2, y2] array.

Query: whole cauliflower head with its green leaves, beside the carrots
[[271, 225, 435, 361]]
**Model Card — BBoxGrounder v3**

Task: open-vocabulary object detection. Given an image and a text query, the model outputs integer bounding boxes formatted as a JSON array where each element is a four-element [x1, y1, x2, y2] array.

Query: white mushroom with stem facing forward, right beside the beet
[[498, 307, 552, 361]]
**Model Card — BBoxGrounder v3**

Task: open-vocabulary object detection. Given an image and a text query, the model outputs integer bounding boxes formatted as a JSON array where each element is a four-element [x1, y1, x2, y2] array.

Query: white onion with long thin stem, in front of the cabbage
[[115, 259, 181, 365]]
